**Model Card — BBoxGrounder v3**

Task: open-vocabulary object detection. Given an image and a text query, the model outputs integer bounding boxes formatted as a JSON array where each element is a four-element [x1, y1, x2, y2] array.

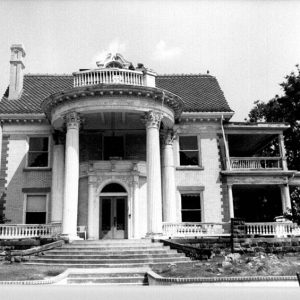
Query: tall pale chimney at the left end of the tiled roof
[[8, 44, 25, 100]]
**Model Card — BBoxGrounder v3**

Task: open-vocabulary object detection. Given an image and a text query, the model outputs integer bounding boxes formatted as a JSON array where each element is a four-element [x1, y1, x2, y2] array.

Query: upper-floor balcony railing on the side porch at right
[[230, 157, 282, 170]]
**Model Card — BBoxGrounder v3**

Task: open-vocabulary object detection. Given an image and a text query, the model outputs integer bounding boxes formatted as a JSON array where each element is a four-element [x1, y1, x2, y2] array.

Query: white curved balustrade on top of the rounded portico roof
[[73, 69, 144, 87]]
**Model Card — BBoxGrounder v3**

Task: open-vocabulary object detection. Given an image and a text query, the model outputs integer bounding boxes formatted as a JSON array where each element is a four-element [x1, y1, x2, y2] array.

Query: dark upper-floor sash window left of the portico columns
[[27, 137, 49, 168]]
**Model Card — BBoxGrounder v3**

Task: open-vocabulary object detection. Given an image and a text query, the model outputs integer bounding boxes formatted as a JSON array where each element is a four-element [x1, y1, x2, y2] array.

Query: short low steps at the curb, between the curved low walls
[[67, 276, 148, 285]]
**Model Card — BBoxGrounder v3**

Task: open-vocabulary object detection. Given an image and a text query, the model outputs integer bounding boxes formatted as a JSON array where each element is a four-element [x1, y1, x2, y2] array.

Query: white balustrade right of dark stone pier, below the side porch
[[245, 222, 300, 237]]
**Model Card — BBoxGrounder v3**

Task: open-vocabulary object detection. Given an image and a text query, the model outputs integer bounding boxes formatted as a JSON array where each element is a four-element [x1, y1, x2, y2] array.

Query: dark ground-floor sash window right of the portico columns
[[181, 193, 201, 222]]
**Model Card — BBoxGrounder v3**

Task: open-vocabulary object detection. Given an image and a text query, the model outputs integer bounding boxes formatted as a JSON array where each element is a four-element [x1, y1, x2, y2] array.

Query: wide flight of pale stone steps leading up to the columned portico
[[26, 240, 191, 268]]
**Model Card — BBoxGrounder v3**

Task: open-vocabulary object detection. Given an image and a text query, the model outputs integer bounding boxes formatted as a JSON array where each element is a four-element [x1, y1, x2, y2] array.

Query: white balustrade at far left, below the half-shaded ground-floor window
[[0, 224, 61, 239]]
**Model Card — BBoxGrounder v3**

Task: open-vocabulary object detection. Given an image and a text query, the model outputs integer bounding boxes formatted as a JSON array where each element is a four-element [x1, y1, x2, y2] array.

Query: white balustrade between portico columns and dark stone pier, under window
[[163, 222, 229, 237]]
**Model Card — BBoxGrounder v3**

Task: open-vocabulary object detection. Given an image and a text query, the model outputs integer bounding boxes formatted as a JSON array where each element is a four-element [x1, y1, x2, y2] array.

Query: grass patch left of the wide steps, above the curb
[[0, 262, 66, 281]]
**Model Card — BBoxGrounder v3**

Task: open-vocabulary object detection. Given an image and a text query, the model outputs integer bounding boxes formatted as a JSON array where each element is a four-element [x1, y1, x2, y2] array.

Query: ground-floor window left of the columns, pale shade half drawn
[[25, 194, 47, 224]]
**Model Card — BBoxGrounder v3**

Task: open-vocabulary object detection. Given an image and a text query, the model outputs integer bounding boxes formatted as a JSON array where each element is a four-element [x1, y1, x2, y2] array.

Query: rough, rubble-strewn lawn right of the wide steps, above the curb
[[154, 253, 300, 278]]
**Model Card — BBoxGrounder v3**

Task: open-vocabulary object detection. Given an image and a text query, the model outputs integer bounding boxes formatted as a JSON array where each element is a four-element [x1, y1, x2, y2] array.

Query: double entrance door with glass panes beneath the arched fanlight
[[100, 196, 127, 239]]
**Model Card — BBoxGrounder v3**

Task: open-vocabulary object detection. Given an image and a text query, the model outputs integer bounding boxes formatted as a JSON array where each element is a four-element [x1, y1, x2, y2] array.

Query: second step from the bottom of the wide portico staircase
[[32, 256, 189, 264]]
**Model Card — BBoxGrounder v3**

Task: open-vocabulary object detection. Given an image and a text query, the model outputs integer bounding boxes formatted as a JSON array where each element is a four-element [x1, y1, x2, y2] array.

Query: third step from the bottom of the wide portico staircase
[[38, 253, 185, 260]]
